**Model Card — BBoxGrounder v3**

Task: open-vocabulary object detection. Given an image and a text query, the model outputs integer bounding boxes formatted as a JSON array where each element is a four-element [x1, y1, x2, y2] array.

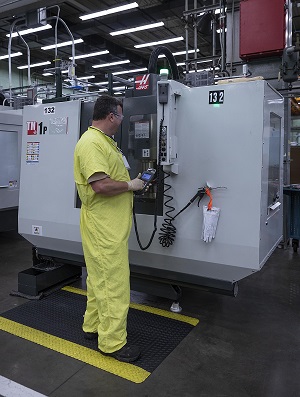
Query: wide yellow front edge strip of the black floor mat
[[0, 317, 150, 383]]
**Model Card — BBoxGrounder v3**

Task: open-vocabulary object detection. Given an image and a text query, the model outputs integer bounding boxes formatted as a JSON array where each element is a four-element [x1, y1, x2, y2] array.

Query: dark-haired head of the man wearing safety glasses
[[92, 95, 123, 136]]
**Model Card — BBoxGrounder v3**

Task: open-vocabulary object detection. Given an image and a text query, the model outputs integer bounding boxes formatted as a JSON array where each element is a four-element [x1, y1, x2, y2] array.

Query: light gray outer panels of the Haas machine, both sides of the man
[[19, 81, 283, 282]]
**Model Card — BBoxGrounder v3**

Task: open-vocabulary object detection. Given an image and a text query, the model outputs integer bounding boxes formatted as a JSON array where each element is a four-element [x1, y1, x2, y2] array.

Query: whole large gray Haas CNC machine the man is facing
[[19, 74, 283, 297]]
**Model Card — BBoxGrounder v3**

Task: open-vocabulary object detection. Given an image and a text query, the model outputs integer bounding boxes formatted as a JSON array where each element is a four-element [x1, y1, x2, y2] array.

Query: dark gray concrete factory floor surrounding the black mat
[[0, 232, 300, 397]]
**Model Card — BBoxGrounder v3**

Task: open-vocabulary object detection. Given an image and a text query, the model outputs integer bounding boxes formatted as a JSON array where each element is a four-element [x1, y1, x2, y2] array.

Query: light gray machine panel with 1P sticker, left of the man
[[19, 101, 82, 253]]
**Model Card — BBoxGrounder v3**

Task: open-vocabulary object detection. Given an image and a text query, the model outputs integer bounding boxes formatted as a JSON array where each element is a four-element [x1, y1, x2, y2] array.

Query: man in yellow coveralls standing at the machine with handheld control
[[74, 95, 144, 362]]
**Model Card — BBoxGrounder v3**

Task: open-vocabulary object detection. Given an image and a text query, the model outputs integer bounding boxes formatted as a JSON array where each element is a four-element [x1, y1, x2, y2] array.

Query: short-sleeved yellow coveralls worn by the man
[[74, 127, 133, 353]]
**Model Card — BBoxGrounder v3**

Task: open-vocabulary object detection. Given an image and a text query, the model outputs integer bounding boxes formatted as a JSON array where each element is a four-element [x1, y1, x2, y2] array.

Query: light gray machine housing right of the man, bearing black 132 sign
[[130, 81, 283, 281]]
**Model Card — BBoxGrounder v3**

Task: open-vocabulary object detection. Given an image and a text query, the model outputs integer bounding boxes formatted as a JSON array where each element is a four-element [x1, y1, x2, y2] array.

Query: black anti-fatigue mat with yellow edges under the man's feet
[[0, 287, 198, 383]]
